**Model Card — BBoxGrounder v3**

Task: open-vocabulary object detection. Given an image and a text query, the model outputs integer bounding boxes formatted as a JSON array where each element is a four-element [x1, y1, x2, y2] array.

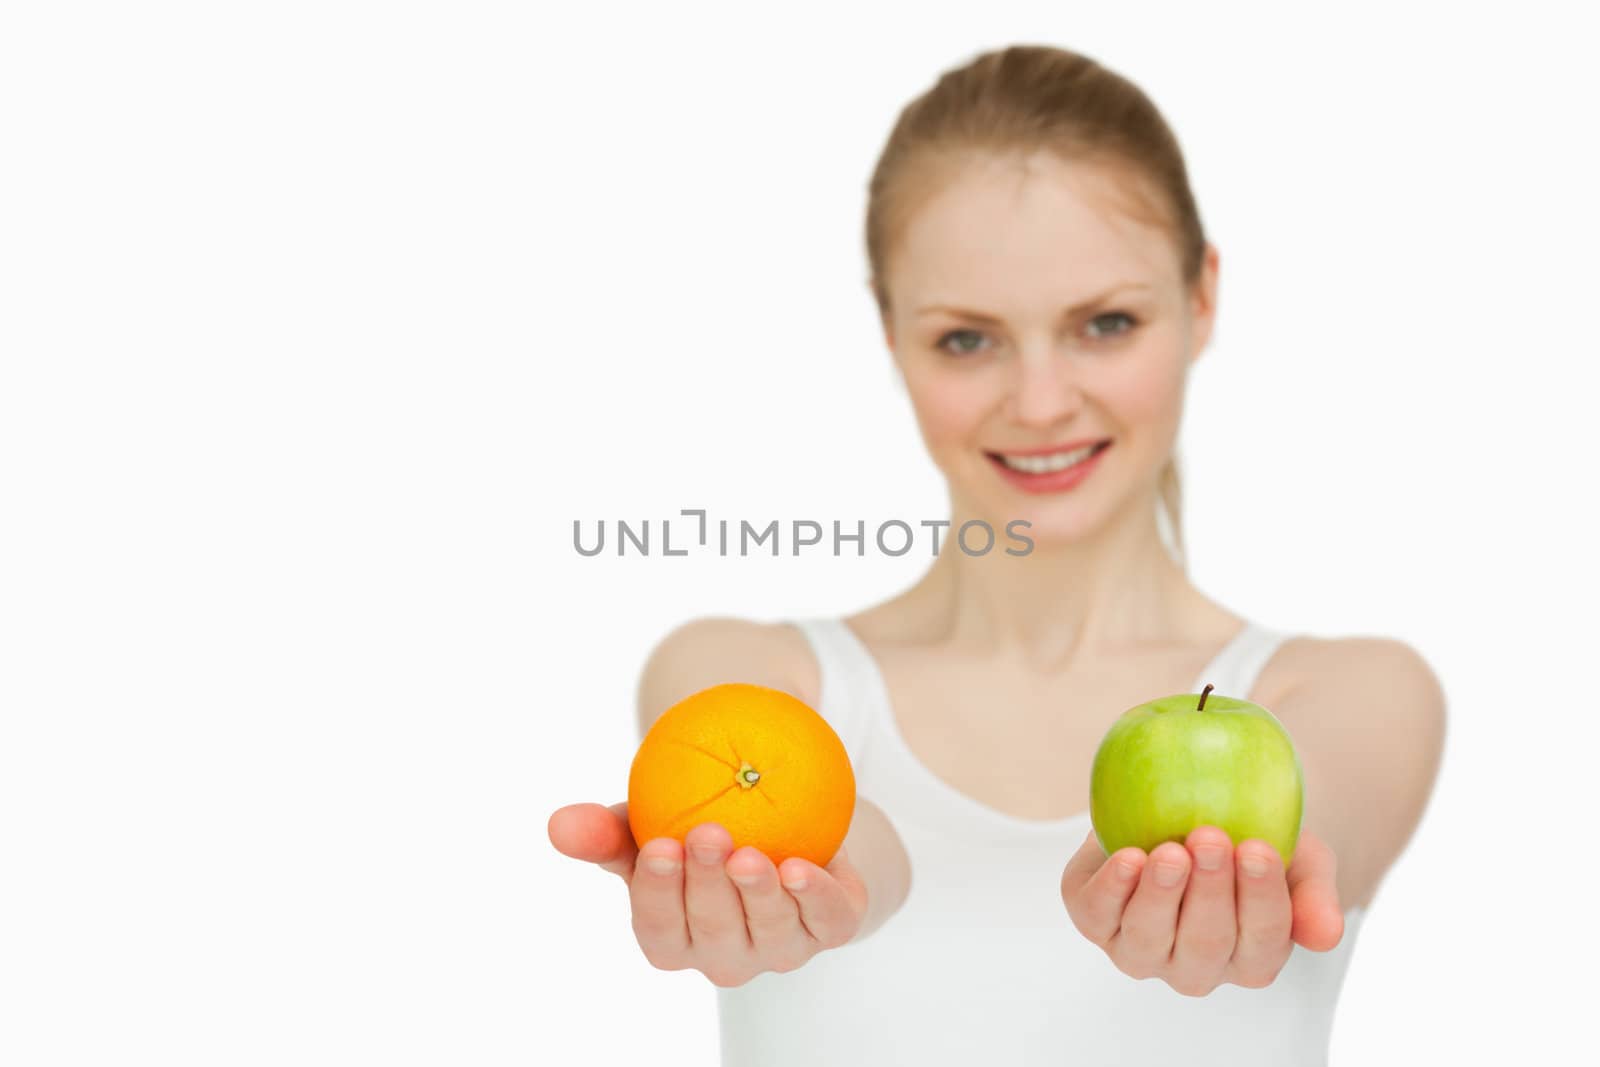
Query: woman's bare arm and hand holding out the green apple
[[1061, 638, 1445, 997]]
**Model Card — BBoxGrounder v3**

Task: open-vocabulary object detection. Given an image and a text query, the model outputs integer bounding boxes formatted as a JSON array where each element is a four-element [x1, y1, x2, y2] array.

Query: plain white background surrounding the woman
[[0, 2, 1600, 1065]]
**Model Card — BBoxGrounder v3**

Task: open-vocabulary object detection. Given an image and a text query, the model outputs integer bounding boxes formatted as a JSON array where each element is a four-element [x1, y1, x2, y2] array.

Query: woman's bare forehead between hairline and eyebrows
[[891, 154, 1179, 310]]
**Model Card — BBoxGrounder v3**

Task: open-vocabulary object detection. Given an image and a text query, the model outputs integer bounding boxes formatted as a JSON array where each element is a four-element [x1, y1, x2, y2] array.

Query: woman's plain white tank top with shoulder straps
[[717, 619, 1362, 1067]]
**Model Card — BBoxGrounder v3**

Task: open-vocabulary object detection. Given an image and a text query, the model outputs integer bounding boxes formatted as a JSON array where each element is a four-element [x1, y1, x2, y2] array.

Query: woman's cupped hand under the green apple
[[1061, 825, 1344, 997]]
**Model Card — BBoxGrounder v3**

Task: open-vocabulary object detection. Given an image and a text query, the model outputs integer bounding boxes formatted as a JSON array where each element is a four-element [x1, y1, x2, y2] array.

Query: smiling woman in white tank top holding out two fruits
[[549, 46, 1445, 1067]]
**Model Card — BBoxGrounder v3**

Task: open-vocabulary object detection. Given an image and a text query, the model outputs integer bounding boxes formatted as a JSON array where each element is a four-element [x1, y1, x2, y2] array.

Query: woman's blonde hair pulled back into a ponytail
[[866, 45, 1206, 565]]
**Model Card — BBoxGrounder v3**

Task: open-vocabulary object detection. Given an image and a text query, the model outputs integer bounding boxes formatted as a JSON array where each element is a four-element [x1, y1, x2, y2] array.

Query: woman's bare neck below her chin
[[909, 496, 1198, 670]]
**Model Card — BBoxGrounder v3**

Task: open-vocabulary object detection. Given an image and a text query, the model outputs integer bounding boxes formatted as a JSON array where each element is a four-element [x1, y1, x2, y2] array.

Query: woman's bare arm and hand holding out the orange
[[549, 619, 910, 987]]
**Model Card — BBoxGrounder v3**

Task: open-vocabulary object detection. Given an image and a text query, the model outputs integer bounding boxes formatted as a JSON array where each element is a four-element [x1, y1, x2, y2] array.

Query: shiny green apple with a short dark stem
[[1090, 685, 1306, 869]]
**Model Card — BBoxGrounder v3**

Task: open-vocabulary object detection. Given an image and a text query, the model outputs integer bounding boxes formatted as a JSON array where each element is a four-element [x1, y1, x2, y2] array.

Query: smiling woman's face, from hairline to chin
[[883, 154, 1218, 545]]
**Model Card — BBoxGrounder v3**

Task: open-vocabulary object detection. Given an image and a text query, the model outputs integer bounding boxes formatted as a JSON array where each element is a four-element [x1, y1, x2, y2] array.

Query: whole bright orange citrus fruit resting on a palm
[[627, 681, 856, 867]]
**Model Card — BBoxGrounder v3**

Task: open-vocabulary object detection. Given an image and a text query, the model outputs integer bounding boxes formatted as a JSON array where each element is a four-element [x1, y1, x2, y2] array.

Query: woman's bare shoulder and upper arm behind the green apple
[[1272, 637, 1446, 907]]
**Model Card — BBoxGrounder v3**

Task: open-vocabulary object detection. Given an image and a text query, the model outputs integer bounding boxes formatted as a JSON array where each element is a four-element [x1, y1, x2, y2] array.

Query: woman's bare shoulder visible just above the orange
[[637, 616, 821, 734]]
